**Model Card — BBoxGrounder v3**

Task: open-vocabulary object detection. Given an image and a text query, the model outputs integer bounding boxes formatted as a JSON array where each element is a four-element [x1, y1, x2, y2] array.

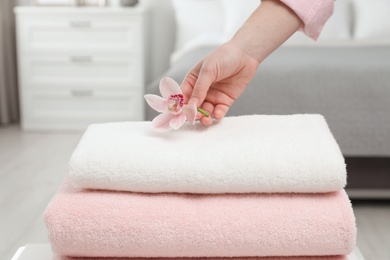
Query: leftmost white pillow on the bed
[[172, 0, 224, 50]]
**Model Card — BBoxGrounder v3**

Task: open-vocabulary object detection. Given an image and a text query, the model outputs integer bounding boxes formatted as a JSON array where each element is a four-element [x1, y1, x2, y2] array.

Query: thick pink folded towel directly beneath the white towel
[[44, 181, 356, 257]]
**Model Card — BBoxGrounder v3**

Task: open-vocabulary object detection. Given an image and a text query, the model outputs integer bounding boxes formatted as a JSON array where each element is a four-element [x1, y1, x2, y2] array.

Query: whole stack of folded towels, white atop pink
[[45, 115, 356, 260]]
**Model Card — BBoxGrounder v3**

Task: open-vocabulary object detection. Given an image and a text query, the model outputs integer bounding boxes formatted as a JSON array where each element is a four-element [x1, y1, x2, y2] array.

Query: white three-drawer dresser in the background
[[15, 6, 147, 130]]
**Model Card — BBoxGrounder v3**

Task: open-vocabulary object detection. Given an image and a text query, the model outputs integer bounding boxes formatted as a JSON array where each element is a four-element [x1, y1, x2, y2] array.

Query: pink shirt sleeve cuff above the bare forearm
[[281, 0, 334, 40]]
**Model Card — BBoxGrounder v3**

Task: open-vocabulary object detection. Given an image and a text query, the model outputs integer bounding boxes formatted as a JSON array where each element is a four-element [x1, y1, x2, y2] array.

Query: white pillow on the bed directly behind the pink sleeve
[[284, 0, 352, 46]]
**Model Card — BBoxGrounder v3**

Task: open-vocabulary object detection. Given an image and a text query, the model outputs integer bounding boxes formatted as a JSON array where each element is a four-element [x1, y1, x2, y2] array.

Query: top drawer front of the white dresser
[[18, 15, 142, 51]]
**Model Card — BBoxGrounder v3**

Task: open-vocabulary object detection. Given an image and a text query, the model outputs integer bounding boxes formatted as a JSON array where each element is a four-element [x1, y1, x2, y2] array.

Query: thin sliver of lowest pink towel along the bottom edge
[[53, 255, 348, 260]]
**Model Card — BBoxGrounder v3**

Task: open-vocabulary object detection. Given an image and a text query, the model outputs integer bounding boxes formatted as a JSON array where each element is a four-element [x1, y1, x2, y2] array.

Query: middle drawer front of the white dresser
[[21, 54, 144, 90]]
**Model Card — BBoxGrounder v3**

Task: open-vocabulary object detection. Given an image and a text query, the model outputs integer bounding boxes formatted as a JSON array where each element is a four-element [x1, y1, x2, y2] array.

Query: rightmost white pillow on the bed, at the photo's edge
[[354, 0, 390, 40]]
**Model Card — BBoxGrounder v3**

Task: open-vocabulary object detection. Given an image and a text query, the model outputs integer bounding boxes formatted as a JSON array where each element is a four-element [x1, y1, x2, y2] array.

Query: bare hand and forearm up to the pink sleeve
[[181, 0, 303, 125]]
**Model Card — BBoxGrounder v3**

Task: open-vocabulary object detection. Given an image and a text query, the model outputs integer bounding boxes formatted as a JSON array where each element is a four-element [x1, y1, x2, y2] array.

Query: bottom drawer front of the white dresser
[[22, 89, 144, 129]]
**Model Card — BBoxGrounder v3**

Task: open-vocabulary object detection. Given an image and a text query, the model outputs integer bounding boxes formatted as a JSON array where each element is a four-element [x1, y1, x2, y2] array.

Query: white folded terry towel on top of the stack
[[69, 115, 346, 193]]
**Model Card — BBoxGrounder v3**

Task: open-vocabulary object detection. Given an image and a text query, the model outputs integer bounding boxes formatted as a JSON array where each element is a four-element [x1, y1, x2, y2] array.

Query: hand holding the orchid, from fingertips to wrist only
[[181, 42, 259, 125]]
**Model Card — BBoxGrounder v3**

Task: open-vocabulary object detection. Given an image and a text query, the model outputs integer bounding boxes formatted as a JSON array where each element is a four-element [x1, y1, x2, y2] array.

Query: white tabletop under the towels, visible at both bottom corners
[[11, 244, 364, 260]]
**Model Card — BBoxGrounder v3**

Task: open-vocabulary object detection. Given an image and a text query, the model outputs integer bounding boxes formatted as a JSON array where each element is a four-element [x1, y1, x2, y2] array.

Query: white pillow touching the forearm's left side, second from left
[[222, 0, 261, 40]]
